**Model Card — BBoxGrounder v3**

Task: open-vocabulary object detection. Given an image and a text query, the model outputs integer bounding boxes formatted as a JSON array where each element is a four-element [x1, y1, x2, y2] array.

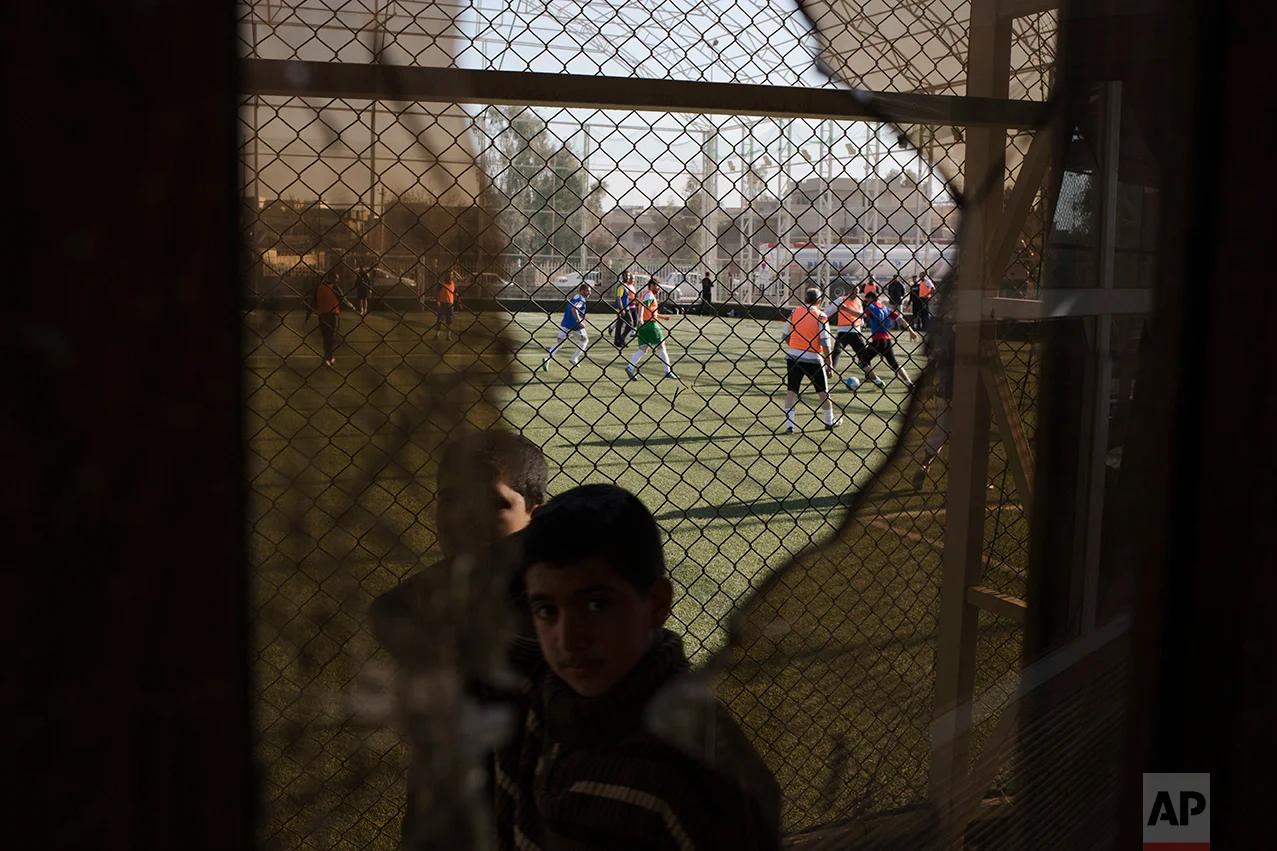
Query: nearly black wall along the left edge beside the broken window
[[7, 0, 255, 850]]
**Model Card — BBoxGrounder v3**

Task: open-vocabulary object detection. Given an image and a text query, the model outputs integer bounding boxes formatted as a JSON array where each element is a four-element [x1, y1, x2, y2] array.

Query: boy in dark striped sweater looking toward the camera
[[493, 484, 780, 851]]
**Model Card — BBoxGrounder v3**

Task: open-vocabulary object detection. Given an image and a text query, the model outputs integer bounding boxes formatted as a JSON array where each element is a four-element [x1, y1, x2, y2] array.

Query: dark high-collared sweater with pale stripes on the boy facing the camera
[[493, 631, 780, 851]]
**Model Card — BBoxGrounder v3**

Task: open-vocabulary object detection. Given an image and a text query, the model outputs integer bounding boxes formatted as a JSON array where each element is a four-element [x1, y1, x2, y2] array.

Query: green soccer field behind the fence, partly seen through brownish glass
[[245, 311, 1018, 848]]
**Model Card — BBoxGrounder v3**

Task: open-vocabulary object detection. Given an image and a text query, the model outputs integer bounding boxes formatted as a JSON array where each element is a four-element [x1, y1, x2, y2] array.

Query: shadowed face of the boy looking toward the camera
[[524, 558, 673, 698]]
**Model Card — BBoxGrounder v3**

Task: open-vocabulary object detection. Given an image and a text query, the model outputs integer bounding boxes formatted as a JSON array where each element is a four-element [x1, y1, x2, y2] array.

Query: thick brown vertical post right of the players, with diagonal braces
[[931, 0, 1011, 845]]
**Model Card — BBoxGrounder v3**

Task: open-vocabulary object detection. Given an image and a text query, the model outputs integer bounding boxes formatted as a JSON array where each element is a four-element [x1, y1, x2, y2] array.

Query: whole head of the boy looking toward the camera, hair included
[[522, 484, 673, 698]]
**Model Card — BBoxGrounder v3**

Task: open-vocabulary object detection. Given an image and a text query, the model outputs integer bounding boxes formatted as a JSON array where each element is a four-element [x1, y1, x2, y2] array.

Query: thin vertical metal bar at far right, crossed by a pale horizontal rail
[[1080, 82, 1121, 635]]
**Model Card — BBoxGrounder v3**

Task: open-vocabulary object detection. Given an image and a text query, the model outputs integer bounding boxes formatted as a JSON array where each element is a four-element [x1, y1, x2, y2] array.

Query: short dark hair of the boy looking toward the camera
[[520, 484, 665, 594]]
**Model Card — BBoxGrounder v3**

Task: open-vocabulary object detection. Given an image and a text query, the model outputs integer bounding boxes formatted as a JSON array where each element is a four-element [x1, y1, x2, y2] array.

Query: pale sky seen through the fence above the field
[[241, 0, 950, 207]]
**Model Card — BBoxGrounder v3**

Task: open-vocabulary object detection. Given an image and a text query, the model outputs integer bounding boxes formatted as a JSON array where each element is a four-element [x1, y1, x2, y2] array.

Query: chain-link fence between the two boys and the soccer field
[[240, 0, 1054, 848]]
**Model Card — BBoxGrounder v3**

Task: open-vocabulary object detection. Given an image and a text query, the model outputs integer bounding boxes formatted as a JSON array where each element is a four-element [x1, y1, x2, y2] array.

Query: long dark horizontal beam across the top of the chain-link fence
[[240, 59, 1047, 130]]
